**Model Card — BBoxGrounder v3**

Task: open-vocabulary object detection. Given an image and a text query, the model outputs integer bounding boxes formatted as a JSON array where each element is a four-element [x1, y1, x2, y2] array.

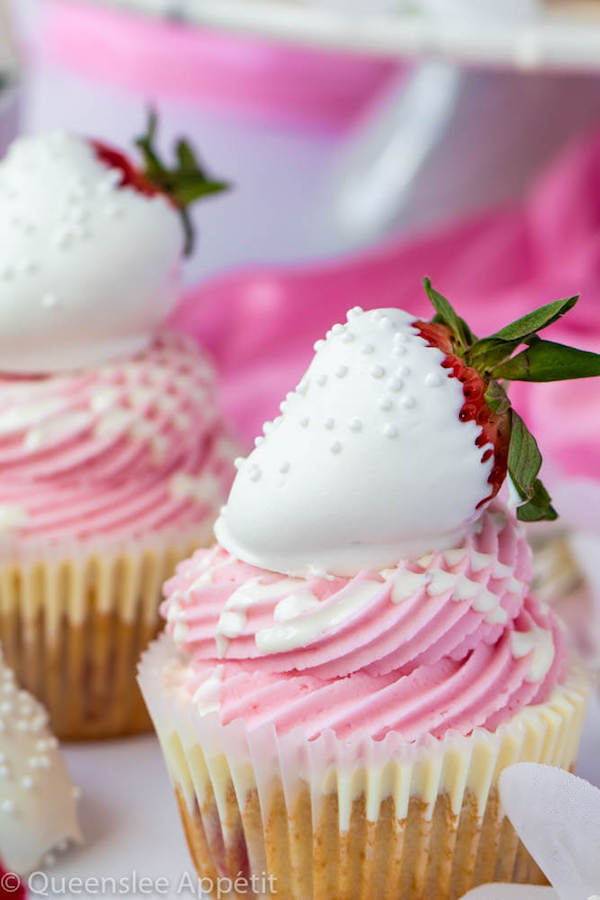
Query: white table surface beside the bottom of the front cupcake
[[24, 695, 600, 898]]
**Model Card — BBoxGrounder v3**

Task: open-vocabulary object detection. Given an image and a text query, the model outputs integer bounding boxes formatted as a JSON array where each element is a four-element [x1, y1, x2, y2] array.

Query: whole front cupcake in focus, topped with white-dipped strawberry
[[140, 283, 600, 900]]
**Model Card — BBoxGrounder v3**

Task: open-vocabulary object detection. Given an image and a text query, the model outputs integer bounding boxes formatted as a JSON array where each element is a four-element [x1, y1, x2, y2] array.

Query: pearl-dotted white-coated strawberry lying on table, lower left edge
[[0, 652, 82, 875]]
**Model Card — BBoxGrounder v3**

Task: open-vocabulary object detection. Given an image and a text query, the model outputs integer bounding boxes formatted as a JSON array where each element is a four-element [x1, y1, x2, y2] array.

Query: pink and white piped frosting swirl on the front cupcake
[[163, 504, 566, 741]]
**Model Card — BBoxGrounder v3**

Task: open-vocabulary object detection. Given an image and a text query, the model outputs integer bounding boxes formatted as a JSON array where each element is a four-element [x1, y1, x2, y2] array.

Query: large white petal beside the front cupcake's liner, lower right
[[498, 763, 600, 900]]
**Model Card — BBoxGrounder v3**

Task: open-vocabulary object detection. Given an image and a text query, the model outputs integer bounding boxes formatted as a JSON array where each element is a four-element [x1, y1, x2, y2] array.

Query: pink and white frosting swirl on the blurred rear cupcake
[[0, 334, 233, 554]]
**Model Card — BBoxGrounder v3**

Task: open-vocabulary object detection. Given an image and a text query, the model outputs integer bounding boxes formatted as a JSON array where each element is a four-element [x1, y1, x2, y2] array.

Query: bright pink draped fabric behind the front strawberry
[[174, 135, 600, 518]]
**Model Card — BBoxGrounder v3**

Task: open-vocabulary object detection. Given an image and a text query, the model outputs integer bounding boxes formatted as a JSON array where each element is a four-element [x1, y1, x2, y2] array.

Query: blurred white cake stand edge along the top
[[74, 0, 600, 71]]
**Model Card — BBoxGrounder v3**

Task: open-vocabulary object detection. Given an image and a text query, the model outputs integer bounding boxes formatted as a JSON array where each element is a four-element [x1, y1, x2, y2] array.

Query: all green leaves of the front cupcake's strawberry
[[424, 278, 600, 522]]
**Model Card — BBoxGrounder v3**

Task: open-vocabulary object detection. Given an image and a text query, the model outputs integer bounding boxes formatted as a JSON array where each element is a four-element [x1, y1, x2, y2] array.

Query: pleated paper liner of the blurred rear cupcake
[[0, 526, 210, 740]]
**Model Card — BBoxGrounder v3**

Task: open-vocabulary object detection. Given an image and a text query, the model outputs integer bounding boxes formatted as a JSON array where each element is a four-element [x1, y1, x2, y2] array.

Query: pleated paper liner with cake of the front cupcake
[[139, 635, 589, 900]]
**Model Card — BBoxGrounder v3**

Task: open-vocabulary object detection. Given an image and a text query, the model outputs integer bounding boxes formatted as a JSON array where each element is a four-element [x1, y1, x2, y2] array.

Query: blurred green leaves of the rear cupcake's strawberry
[[135, 110, 229, 256]]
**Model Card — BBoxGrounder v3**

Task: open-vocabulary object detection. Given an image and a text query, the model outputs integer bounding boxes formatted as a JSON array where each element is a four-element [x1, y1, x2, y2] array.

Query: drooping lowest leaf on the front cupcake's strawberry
[[508, 409, 558, 522]]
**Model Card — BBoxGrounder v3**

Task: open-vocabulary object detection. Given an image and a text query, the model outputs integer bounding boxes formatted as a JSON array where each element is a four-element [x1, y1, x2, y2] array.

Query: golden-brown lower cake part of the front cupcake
[[176, 787, 547, 900]]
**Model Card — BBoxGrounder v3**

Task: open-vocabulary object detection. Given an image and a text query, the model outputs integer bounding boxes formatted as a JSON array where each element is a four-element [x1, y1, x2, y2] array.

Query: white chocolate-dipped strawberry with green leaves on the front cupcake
[[215, 281, 600, 576]]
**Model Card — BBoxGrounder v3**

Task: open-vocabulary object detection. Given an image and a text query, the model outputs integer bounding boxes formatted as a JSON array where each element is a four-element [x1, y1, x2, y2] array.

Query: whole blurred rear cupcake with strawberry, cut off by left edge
[[0, 119, 233, 738]]
